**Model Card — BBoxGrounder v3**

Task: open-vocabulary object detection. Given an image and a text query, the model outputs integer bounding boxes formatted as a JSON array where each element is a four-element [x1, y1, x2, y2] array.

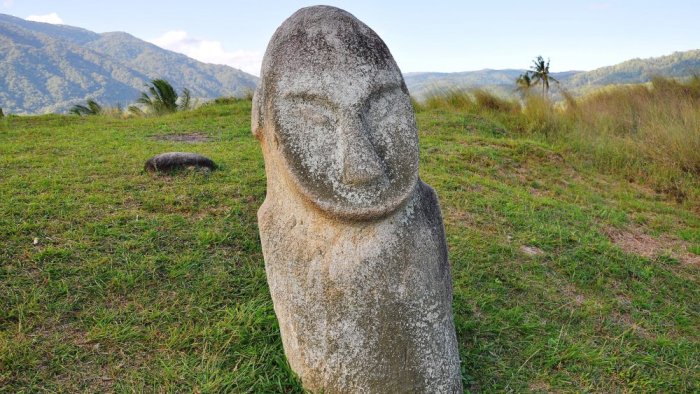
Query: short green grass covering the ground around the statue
[[0, 101, 700, 393]]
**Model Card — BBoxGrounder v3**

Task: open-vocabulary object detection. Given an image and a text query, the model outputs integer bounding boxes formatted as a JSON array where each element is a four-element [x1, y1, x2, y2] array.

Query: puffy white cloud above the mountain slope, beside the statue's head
[[149, 30, 263, 75]]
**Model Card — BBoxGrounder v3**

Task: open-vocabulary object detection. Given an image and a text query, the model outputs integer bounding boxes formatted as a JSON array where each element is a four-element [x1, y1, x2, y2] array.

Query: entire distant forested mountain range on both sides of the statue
[[0, 14, 700, 114]]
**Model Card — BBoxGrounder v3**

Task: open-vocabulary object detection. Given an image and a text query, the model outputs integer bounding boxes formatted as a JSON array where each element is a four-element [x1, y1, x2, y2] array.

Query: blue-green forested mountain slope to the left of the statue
[[0, 14, 257, 113]]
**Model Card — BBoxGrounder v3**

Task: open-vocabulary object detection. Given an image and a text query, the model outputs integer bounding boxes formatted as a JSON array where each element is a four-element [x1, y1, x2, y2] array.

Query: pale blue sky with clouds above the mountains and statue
[[0, 0, 700, 75]]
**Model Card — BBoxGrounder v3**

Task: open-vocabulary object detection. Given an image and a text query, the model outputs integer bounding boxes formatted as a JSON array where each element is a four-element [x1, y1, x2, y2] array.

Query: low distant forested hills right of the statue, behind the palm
[[406, 50, 700, 98]]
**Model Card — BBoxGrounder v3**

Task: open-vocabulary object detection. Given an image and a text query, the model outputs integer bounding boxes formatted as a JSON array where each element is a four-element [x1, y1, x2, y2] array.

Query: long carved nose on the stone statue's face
[[341, 119, 384, 185]]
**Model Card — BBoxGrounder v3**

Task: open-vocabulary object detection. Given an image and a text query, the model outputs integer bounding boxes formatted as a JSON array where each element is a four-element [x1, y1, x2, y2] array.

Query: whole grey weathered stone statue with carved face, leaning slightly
[[252, 6, 462, 393]]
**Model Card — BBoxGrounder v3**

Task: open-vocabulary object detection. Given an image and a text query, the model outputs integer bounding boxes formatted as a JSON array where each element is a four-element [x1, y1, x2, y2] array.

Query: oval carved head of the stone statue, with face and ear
[[252, 6, 418, 219]]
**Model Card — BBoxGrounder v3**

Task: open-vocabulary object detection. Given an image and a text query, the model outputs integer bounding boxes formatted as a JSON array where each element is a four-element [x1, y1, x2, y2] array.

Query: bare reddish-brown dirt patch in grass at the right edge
[[605, 228, 700, 266]]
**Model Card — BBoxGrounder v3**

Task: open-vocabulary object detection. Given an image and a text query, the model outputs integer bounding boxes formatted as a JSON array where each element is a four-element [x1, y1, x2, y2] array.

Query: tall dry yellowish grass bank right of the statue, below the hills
[[417, 76, 700, 205]]
